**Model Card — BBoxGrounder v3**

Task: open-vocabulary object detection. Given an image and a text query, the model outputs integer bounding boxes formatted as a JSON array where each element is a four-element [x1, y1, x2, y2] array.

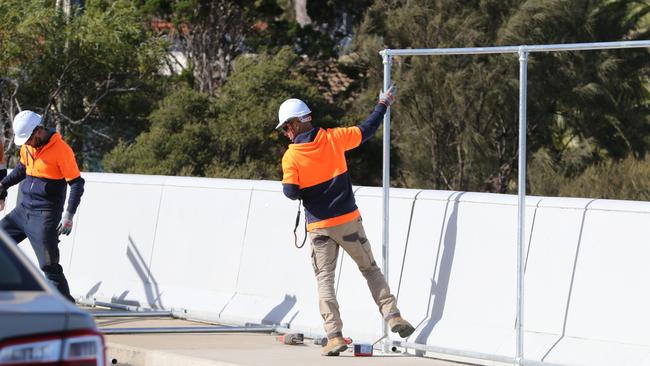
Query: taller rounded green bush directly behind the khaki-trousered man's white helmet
[[209, 47, 337, 179]]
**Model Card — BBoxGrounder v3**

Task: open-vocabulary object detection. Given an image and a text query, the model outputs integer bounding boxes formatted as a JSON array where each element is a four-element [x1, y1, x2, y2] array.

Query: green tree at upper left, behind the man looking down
[[0, 0, 164, 169]]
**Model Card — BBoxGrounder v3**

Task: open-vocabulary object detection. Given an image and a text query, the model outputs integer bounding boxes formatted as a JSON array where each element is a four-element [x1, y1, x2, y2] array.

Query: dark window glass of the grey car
[[0, 242, 43, 291]]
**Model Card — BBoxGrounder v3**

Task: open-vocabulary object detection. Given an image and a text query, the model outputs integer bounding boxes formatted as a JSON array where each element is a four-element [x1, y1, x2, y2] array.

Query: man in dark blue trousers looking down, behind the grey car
[[0, 111, 84, 303]]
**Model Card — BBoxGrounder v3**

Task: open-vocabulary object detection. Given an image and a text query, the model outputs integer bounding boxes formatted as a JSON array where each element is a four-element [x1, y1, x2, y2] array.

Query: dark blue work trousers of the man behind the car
[[0, 204, 74, 302]]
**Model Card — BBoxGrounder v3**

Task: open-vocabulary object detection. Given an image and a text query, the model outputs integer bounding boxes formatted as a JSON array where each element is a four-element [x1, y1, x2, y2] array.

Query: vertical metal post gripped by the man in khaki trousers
[[381, 50, 393, 352]]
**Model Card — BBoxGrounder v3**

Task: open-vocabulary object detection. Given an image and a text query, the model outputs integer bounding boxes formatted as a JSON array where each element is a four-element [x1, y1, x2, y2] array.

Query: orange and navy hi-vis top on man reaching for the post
[[282, 104, 386, 231]]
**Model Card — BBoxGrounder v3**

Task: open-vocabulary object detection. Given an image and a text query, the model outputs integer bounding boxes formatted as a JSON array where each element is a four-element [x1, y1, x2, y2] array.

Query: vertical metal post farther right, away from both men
[[516, 47, 528, 365]]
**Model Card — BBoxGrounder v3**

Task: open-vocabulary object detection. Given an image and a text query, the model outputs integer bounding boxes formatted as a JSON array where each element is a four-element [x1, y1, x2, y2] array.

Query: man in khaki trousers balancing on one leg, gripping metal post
[[276, 87, 415, 356]]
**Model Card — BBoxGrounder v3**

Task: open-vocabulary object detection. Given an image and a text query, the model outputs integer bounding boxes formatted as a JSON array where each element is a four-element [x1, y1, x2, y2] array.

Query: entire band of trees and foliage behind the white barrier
[[0, 0, 650, 202]]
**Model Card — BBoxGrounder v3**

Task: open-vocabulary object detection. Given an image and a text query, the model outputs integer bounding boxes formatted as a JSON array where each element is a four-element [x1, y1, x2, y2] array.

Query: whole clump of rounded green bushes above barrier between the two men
[[105, 48, 337, 179]]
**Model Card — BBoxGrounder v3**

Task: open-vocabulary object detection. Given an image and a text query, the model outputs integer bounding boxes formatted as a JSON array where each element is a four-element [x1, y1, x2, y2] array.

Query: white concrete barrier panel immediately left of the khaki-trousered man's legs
[[221, 181, 323, 334]]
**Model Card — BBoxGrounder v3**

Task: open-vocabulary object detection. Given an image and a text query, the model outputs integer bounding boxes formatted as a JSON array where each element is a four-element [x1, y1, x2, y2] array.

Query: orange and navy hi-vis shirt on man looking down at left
[[1, 132, 84, 214]]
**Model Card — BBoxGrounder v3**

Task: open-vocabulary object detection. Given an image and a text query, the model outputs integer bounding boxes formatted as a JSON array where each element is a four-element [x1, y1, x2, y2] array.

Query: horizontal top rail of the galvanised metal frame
[[379, 40, 650, 56]]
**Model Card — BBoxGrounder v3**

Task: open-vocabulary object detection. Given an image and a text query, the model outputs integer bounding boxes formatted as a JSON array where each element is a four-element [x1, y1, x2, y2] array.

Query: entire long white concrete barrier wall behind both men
[[5, 173, 650, 366]]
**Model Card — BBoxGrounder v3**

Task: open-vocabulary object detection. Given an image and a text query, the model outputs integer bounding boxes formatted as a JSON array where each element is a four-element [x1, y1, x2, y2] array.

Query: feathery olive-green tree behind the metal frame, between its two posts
[[356, 1, 517, 192]]
